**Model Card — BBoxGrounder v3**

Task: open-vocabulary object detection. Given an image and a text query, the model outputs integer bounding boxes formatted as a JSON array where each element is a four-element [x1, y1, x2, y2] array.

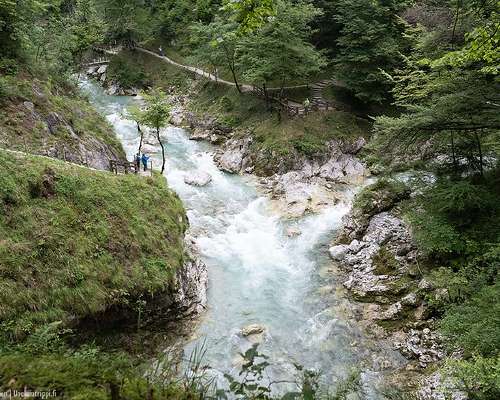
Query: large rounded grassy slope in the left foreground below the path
[[0, 151, 187, 337]]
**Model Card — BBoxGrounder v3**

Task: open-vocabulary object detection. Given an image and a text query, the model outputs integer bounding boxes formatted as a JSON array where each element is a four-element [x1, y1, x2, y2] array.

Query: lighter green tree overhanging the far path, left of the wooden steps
[[237, 0, 326, 105]]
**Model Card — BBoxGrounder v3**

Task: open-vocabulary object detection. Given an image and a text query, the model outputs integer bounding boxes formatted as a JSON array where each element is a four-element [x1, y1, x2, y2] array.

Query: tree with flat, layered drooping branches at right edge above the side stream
[[375, 53, 500, 174]]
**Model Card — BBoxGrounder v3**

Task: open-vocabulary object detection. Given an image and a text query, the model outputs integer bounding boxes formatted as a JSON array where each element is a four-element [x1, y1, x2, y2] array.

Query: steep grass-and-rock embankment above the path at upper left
[[0, 73, 125, 169]]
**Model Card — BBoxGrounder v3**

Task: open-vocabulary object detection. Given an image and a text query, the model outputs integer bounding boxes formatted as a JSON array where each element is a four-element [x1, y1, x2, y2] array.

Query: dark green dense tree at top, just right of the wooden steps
[[334, 0, 407, 103]]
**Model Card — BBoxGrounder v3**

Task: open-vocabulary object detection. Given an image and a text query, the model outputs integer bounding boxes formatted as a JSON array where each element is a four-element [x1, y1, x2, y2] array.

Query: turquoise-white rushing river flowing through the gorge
[[81, 80, 403, 399]]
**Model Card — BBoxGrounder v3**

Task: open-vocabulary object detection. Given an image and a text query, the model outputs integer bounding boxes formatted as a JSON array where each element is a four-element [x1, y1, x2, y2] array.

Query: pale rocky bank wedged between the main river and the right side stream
[[171, 102, 370, 218]]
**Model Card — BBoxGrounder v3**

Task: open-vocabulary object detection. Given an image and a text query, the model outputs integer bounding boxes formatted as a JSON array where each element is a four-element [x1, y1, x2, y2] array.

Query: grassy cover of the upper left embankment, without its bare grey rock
[[0, 73, 124, 157]]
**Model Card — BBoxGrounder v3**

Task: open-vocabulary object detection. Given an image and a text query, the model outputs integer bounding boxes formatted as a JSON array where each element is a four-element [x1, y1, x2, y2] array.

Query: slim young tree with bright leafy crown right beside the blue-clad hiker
[[139, 89, 170, 174]]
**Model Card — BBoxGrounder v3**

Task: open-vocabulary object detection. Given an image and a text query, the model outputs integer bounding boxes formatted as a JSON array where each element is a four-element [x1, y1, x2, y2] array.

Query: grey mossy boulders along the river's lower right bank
[[329, 184, 465, 400]]
